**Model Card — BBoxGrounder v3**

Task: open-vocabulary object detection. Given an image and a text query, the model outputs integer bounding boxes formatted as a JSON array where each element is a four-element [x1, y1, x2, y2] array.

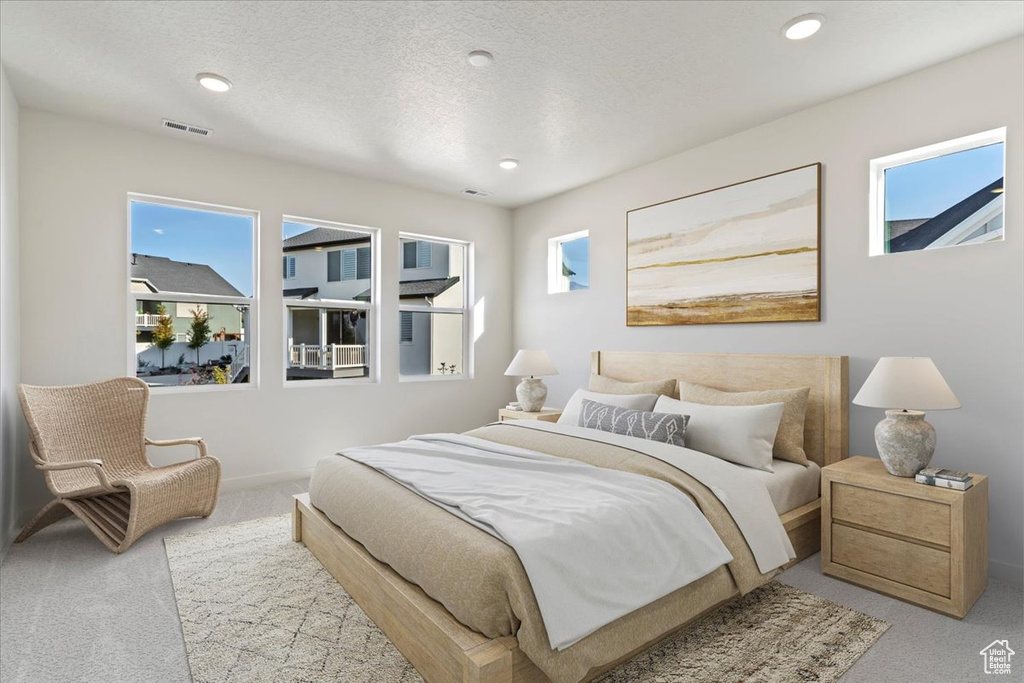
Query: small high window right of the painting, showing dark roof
[[868, 128, 1007, 256]]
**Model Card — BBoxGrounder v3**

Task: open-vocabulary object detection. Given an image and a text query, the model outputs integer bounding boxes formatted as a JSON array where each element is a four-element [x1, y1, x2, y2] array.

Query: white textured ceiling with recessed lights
[[0, 0, 1024, 206]]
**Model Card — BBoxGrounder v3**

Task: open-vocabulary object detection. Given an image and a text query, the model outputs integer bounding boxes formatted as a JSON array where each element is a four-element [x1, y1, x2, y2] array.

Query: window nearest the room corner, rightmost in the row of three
[[398, 236, 473, 380]]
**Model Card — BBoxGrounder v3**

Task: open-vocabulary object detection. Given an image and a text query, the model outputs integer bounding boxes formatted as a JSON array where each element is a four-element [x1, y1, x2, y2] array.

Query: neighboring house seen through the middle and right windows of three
[[282, 227, 463, 379]]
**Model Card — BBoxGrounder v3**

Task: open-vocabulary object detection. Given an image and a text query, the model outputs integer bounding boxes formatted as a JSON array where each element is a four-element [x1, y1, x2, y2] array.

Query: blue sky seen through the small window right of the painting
[[886, 142, 1004, 220]]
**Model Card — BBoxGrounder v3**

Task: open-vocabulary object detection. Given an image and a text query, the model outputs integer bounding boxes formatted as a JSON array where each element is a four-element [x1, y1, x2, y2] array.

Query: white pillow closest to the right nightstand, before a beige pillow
[[654, 396, 785, 472]]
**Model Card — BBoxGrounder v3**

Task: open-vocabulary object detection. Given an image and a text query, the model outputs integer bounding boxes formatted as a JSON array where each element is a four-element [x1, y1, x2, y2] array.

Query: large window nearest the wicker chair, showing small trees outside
[[128, 195, 259, 387]]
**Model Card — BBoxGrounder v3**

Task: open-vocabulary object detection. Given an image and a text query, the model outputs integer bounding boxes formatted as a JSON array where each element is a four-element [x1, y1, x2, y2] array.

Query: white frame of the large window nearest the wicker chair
[[124, 191, 260, 395]]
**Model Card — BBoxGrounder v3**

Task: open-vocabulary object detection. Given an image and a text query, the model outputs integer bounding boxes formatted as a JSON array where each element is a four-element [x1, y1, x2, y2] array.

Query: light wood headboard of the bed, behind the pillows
[[590, 351, 850, 467]]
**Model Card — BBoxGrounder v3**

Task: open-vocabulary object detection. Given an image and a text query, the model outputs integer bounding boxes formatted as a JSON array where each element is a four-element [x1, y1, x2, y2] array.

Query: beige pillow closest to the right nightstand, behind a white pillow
[[679, 380, 811, 465]]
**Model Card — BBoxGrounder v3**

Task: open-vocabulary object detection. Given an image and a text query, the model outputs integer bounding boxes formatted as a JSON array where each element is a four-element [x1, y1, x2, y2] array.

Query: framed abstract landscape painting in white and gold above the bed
[[626, 164, 821, 326]]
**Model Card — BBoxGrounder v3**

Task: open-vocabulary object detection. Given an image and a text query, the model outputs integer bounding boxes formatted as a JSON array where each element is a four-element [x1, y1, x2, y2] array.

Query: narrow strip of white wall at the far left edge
[[0, 67, 28, 558]]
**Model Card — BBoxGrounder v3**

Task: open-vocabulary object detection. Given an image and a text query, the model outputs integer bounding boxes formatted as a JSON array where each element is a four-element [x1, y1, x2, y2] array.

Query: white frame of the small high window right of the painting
[[867, 127, 1007, 258]]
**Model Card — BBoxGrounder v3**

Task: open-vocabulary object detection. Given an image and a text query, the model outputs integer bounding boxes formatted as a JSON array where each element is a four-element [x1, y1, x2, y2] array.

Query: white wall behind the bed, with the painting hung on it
[[513, 39, 1024, 582]]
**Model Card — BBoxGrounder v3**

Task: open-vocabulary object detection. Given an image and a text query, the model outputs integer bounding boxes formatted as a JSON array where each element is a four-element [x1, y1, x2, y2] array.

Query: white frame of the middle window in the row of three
[[281, 214, 381, 389]]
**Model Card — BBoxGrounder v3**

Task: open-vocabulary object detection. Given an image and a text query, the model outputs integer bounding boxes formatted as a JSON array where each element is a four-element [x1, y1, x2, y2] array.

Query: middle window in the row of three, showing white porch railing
[[282, 218, 379, 382]]
